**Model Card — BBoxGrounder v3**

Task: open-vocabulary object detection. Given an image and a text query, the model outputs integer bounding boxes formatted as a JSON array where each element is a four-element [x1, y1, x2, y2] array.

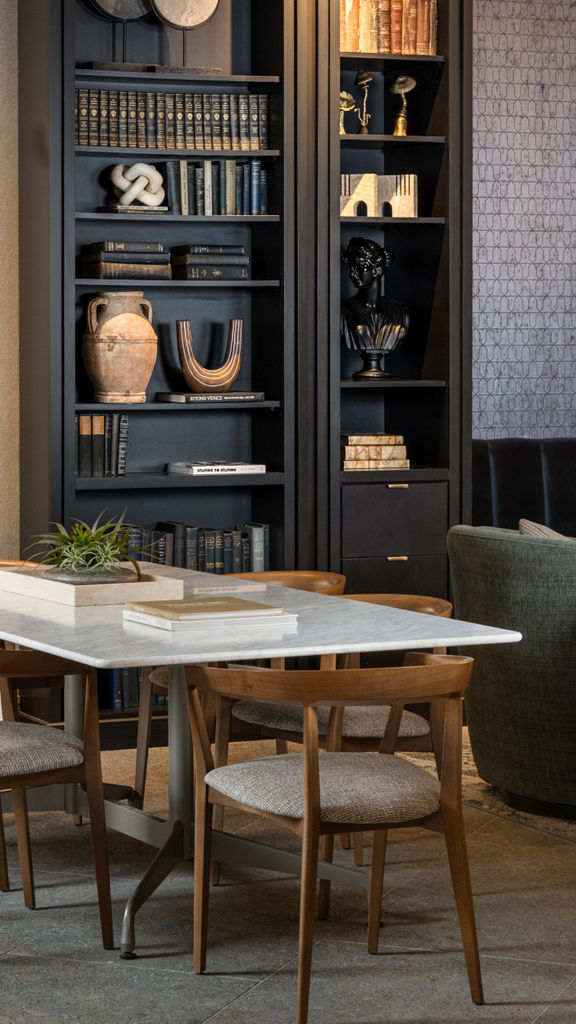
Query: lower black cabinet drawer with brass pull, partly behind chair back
[[341, 555, 448, 598]]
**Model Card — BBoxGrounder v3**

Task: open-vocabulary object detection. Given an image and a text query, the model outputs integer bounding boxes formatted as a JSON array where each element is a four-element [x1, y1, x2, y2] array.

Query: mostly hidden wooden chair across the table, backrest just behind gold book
[[134, 569, 346, 808]]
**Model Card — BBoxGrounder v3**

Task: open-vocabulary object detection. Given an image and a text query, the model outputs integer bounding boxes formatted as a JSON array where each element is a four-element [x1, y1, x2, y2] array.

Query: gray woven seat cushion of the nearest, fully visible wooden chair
[[206, 753, 440, 825]]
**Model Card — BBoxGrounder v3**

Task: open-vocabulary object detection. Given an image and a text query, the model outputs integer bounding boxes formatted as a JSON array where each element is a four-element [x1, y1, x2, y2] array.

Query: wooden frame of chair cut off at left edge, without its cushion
[[0, 650, 114, 949]]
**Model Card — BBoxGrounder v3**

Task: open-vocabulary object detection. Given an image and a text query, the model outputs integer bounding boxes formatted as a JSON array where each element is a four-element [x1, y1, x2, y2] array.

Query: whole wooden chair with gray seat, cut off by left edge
[[0, 650, 114, 949]]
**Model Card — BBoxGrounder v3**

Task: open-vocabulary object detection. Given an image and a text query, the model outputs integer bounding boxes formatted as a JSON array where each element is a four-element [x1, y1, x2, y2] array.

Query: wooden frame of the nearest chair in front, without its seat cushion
[[186, 653, 484, 1024]]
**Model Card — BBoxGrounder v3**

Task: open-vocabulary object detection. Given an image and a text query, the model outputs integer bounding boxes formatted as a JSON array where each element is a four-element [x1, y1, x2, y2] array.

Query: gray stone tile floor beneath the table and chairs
[[0, 751, 576, 1024]]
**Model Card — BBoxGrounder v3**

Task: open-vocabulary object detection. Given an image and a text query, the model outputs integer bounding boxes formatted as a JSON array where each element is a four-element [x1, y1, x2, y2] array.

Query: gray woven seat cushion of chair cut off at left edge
[[0, 722, 84, 781]]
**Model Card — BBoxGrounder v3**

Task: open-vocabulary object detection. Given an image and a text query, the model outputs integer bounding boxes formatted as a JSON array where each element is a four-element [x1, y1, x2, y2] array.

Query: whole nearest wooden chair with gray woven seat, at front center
[[186, 653, 484, 1024]]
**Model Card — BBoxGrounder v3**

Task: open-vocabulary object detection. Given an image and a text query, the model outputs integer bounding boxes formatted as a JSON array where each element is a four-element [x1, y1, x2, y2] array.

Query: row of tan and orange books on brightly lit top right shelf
[[340, 0, 438, 55]]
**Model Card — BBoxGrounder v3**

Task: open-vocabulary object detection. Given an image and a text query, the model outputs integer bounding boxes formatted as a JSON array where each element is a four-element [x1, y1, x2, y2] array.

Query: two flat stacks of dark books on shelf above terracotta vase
[[80, 242, 250, 281]]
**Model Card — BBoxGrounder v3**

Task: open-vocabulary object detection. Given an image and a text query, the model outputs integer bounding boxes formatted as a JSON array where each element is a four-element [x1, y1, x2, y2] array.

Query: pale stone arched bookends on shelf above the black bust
[[340, 174, 418, 217]]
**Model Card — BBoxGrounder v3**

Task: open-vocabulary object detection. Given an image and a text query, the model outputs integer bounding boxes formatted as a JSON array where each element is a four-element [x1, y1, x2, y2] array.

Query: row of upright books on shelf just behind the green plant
[[129, 521, 270, 574]]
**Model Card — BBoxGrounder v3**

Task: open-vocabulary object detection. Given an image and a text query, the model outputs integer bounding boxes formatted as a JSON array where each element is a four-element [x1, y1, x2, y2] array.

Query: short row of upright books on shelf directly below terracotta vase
[[75, 413, 129, 477]]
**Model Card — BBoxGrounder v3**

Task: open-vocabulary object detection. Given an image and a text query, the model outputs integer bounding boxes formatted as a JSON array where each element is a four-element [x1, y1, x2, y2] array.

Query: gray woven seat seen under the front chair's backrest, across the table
[[232, 700, 430, 739]]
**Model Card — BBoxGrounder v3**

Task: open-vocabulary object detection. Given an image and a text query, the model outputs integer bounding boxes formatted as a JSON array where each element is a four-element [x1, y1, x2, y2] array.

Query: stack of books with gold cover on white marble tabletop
[[122, 595, 298, 636]]
